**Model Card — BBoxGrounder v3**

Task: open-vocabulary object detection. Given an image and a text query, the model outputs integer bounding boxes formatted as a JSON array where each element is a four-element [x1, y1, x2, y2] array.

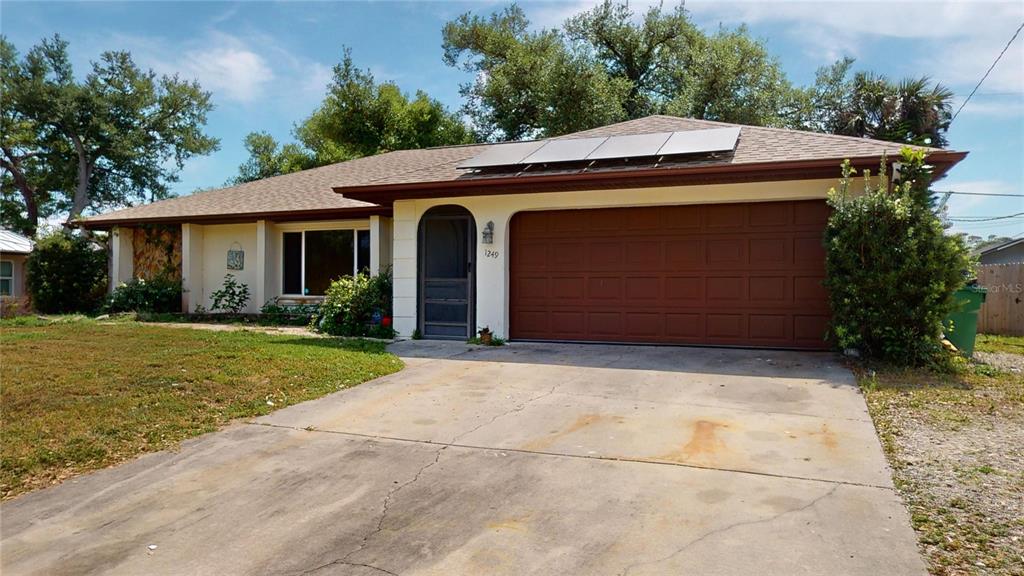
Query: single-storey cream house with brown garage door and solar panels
[[84, 116, 967, 348]]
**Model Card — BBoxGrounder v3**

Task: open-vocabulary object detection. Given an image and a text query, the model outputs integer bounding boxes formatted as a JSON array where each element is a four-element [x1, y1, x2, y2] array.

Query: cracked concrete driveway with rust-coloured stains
[[0, 341, 925, 576]]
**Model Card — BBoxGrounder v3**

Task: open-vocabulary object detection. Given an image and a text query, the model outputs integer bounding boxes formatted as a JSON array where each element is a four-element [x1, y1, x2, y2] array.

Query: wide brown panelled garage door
[[509, 201, 828, 348]]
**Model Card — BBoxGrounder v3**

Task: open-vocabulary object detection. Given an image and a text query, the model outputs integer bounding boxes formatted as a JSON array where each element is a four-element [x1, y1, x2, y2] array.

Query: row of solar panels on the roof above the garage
[[457, 126, 739, 168]]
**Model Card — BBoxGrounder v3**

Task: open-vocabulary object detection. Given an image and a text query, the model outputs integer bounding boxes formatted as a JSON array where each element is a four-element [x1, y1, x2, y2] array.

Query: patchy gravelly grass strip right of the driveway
[[858, 356, 1024, 576]]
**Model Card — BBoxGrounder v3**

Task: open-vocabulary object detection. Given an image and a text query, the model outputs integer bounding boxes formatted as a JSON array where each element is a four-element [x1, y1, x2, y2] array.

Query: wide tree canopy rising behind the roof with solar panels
[[442, 0, 952, 146]]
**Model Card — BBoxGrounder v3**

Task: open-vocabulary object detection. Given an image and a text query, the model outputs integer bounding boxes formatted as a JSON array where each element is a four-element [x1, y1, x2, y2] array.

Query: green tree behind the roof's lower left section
[[232, 49, 472, 183]]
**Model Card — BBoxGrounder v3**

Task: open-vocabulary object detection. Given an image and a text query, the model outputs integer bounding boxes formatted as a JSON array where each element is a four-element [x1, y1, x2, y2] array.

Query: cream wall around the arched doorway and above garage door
[[393, 179, 847, 337]]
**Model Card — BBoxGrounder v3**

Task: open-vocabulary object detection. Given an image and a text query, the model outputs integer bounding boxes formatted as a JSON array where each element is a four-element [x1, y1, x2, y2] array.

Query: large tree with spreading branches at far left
[[0, 36, 218, 236]]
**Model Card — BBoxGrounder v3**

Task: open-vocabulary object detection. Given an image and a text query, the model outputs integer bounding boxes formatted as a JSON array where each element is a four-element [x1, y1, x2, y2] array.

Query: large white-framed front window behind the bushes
[[282, 230, 370, 296]]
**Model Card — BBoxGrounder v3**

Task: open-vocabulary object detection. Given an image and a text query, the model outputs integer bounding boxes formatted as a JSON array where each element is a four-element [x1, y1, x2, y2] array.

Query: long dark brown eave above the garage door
[[333, 151, 968, 206]]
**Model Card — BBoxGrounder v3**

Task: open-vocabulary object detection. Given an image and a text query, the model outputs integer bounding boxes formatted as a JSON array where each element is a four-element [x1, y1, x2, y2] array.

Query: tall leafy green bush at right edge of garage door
[[825, 148, 971, 366]]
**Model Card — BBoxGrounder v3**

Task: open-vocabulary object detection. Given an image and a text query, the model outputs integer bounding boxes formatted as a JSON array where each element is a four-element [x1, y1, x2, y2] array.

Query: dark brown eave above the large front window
[[73, 206, 391, 230]]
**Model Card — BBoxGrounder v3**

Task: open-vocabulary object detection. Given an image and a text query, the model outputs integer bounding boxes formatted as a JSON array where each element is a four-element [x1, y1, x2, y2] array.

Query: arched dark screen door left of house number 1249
[[417, 205, 476, 340]]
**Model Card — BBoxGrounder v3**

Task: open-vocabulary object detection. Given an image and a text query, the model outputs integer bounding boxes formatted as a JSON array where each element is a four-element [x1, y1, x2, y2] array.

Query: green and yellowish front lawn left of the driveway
[[0, 319, 402, 498]]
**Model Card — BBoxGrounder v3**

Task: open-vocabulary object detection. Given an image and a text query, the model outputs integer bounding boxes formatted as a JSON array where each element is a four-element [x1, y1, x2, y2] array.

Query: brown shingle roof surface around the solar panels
[[85, 116, 962, 227]]
